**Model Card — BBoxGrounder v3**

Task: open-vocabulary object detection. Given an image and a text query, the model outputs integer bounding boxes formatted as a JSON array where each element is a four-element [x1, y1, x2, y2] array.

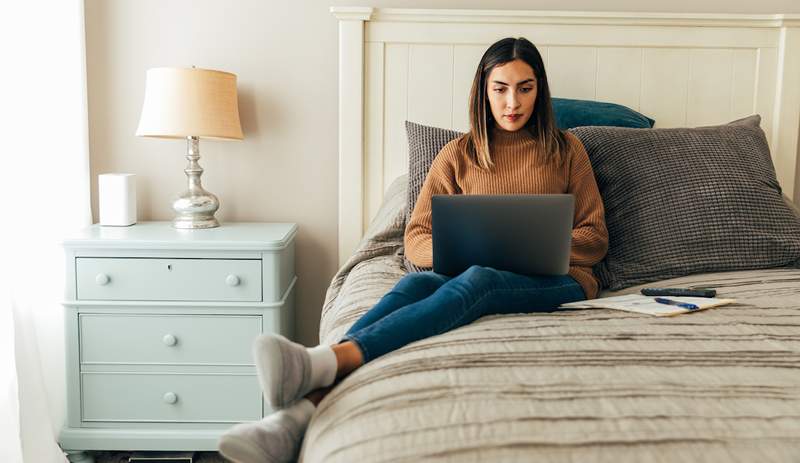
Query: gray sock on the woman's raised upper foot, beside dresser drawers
[[253, 334, 337, 410]]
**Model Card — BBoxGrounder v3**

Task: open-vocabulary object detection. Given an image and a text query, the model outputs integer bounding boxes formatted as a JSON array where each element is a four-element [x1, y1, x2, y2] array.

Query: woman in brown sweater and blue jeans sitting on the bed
[[220, 38, 608, 463]]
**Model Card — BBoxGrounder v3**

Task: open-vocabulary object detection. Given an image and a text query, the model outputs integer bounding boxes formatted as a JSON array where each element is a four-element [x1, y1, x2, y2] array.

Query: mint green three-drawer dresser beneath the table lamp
[[59, 222, 297, 462]]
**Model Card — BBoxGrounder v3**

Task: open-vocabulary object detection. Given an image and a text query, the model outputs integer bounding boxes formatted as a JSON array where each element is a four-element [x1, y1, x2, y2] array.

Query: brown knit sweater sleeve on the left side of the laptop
[[404, 142, 459, 268]]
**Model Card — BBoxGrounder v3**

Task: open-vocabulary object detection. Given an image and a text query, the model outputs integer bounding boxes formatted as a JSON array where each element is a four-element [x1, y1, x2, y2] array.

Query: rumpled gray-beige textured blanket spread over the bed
[[301, 178, 800, 462]]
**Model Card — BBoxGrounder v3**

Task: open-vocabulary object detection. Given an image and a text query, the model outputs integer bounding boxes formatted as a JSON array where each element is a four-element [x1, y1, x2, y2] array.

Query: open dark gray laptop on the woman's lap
[[431, 194, 575, 276]]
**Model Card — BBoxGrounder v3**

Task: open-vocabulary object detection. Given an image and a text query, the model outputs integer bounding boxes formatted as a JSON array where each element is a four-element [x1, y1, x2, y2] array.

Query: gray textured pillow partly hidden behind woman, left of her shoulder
[[403, 121, 463, 272]]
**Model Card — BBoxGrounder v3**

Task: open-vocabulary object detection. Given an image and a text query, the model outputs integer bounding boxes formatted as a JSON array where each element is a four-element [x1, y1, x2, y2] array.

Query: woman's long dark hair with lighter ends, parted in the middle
[[458, 37, 567, 169]]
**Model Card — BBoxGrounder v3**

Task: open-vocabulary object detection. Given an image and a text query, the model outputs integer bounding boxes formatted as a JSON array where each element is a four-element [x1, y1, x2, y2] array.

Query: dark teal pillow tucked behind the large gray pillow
[[552, 98, 656, 130]]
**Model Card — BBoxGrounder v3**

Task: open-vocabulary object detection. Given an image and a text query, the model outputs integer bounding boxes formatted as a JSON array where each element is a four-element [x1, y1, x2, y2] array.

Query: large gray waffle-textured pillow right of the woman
[[569, 115, 800, 290]]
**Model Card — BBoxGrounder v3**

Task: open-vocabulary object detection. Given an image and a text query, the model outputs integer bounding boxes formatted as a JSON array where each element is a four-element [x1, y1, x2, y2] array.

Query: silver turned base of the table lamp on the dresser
[[172, 137, 219, 229]]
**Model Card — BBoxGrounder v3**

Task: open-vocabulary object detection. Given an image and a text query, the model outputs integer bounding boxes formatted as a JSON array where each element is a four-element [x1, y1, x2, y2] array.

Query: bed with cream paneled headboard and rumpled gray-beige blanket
[[300, 7, 800, 462]]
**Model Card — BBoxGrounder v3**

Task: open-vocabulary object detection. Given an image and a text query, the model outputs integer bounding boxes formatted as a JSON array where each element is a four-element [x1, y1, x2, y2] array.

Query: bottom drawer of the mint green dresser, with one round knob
[[81, 373, 261, 423]]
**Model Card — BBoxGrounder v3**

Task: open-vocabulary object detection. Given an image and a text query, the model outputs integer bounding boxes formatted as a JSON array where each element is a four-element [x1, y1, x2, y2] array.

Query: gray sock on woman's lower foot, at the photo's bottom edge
[[218, 399, 315, 463]]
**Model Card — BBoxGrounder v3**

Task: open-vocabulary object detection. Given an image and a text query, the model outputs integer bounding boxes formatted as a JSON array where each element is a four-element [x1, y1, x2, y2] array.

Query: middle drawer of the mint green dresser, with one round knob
[[78, 314, 261, 365]]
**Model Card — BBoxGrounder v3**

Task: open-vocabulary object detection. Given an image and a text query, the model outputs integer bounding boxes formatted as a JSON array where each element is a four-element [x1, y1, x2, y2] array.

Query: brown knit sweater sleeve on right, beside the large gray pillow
[[567, 134, 608, 267]]
